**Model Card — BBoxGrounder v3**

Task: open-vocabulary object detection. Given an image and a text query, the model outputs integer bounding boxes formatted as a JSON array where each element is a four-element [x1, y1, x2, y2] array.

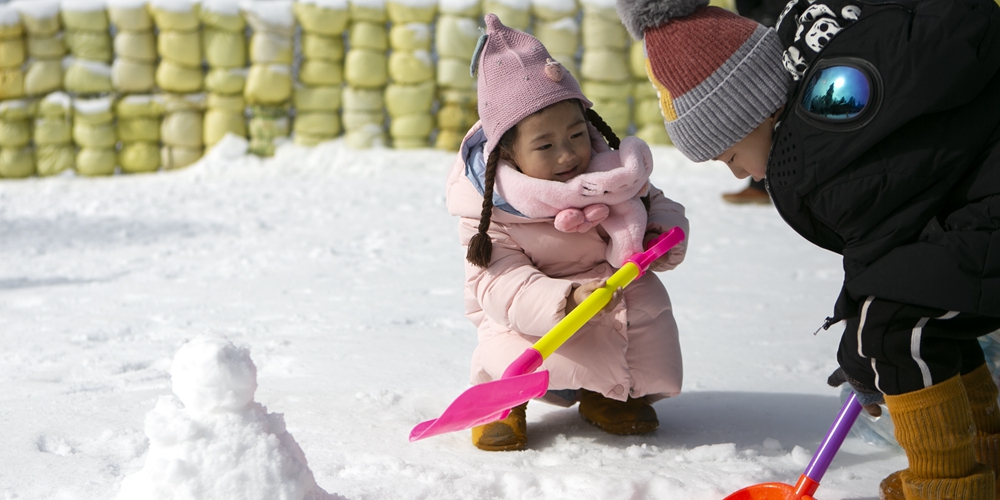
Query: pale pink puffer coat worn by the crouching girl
[[447, 124, 688, 401]]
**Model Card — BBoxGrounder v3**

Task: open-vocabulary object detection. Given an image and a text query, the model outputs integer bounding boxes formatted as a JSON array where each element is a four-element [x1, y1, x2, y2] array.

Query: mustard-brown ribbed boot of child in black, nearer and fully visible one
[[879, 375, 996, 500]]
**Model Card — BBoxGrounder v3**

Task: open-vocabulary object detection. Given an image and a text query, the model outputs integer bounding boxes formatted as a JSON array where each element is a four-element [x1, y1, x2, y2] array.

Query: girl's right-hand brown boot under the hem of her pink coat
[[580, 389, 660, 435]]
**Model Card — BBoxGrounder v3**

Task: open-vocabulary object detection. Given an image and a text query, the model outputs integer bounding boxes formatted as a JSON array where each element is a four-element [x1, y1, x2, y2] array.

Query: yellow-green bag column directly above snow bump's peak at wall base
[[201, 0, 247, 148]]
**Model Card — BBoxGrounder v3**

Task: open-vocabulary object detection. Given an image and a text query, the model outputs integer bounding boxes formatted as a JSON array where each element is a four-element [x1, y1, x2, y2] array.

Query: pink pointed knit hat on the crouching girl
[[472, 14, 593, 157]]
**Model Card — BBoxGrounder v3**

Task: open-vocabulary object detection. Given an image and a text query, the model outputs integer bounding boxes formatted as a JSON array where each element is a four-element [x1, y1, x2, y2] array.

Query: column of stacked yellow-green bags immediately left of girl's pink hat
[[434, 0, 480, 151]]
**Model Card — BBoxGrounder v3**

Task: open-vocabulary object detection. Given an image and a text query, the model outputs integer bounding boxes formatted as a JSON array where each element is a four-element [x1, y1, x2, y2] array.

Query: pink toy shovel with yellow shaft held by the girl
[[410, 227, 684, 441]]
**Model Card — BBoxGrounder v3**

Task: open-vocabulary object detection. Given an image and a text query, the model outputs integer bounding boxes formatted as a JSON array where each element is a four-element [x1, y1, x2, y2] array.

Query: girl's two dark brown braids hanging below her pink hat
[[465, 101, 621, 269]]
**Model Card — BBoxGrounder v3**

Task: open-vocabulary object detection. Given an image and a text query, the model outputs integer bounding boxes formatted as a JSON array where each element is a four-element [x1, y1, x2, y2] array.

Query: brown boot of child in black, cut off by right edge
[[962, 364, 1000, 499]]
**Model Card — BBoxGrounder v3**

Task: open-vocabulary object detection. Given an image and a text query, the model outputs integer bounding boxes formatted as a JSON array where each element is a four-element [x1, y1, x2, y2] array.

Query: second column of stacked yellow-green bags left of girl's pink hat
[[385, 0, 437, 149]]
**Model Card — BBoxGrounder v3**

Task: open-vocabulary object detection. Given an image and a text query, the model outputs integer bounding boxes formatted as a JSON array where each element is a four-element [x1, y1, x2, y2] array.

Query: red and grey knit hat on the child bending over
[[616, 0, 791, 161]]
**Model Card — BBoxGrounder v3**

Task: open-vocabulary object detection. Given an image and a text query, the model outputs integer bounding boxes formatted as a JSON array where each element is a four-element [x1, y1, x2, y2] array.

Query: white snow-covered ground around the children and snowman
[[0, 135, 905, 500]]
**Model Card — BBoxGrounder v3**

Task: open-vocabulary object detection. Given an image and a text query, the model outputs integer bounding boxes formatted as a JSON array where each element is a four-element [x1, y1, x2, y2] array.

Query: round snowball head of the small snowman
[[170, 335, 257, 412]]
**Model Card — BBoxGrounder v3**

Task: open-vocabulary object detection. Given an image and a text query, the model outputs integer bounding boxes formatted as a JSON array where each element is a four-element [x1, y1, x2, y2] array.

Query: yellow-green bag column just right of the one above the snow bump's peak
[[242, 0, 295, 156]]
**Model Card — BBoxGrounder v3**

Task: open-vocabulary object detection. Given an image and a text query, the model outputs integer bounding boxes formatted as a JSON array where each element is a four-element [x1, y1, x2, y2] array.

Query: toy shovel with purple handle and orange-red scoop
[[723, 392, 861, 500]]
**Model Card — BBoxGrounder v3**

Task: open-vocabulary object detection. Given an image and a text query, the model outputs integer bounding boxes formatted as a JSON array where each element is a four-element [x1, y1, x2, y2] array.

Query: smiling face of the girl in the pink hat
[[509, 101, 591, 182]]
